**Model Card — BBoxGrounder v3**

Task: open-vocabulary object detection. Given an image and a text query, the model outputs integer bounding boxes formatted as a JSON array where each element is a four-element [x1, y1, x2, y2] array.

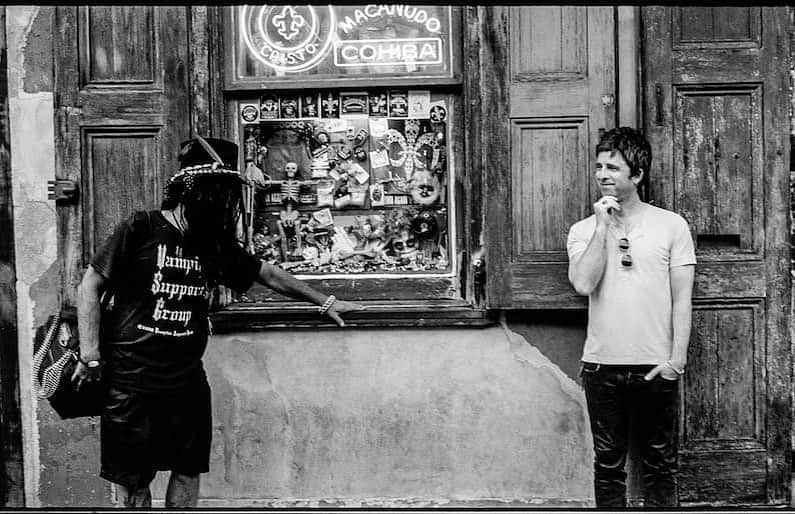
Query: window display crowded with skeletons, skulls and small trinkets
[[238, 88, 455, 275]]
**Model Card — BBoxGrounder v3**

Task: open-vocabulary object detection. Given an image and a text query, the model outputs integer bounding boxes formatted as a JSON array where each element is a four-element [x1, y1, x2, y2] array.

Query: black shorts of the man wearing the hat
[[99, 382, 212, 489]]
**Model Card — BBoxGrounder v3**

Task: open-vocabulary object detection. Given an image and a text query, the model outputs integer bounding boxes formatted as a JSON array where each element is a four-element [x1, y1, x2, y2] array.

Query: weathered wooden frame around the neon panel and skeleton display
[[209, 6, 493, 326]]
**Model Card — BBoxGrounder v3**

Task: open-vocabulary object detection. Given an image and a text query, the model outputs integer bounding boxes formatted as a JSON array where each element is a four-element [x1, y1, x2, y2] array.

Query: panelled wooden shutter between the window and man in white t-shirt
[[480, 6, 617, 308]]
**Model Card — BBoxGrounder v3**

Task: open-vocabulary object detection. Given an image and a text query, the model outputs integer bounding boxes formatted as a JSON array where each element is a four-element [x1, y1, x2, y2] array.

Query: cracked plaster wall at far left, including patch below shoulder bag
[[4, 6, 107, 507]]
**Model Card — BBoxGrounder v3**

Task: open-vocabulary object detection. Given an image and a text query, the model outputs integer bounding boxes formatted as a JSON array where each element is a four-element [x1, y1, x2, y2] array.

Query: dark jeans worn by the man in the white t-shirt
[[581, 362, 679, 507]]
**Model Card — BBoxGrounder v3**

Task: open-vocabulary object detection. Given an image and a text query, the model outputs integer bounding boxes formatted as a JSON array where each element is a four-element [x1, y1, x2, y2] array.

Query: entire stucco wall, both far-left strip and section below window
[[5, 6, 591, 507]]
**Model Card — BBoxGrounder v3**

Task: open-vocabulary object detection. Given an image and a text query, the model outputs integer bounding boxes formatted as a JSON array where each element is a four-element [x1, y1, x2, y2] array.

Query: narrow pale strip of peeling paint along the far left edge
[[5, 6, 57, 507]]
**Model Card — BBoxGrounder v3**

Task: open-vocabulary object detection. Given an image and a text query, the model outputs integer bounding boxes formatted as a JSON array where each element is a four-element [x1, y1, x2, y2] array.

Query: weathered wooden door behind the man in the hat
[[54, 5, 191, 305]]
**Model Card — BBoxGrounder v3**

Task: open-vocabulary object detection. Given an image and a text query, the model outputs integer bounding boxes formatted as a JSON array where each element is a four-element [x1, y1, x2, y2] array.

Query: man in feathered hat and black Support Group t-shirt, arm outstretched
[[72, 137, 363, 507]]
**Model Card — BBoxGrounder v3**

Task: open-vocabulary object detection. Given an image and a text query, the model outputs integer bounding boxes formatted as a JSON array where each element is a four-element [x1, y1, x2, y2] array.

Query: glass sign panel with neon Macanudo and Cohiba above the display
[[237, 4, 450, 77]]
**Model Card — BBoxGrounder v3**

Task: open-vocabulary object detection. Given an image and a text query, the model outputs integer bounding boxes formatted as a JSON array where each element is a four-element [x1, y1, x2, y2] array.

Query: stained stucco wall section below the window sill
[[155, 326, 592, 506]]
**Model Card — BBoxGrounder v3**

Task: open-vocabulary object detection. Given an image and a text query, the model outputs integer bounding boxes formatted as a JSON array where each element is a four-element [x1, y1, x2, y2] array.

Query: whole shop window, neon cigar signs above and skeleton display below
[[216, 5, 478, 320]]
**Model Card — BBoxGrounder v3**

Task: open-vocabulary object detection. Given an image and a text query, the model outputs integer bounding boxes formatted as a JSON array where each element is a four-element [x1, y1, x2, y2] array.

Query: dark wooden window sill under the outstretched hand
[[211, 300, 495, 334]]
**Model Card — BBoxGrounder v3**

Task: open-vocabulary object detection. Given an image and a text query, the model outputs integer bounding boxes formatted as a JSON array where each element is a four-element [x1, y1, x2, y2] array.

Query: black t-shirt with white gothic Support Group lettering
[[91, 211, 260, 392]]
